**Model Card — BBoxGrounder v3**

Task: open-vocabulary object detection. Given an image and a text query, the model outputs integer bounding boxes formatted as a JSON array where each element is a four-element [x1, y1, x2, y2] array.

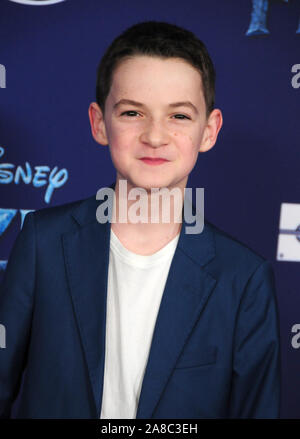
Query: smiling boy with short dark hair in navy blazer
[[0, 22, 280, 419]]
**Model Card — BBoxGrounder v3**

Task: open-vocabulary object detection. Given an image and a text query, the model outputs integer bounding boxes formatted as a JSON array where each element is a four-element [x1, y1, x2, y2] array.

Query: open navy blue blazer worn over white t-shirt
[[0, 183, 280, 419]]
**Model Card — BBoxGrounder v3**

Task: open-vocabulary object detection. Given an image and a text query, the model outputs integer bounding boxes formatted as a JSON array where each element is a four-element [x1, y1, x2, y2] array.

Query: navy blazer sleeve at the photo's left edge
[[0, 212, 36, 418]]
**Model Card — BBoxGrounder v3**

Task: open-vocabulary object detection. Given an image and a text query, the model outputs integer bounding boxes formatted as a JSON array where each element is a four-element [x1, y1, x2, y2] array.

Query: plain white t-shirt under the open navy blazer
[[100, 229, 180, 419]]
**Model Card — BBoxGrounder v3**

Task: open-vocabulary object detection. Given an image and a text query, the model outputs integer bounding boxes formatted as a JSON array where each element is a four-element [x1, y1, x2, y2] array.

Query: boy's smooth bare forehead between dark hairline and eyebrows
[[110, 55, 203, 100]]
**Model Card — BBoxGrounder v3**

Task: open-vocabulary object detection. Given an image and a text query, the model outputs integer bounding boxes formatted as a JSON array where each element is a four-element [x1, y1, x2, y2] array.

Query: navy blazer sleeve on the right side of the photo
[[229, 261, 281, 418]]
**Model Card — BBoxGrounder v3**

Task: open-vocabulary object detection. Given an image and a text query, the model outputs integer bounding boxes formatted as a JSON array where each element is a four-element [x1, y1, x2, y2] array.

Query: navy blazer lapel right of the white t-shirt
[[136, 199, 216, 418]]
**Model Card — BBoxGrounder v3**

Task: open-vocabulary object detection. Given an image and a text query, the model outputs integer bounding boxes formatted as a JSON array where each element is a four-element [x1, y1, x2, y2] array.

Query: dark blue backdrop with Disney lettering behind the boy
[[0, 0, 300, 419]]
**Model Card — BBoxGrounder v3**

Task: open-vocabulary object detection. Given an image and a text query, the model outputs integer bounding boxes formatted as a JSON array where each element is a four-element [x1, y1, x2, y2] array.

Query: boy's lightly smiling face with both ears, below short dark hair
[[89, 56, 222, 190]]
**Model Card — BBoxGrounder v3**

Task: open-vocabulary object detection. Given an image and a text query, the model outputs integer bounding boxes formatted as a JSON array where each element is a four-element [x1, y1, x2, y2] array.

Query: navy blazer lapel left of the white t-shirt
[[62, 196, 110, 418]]
